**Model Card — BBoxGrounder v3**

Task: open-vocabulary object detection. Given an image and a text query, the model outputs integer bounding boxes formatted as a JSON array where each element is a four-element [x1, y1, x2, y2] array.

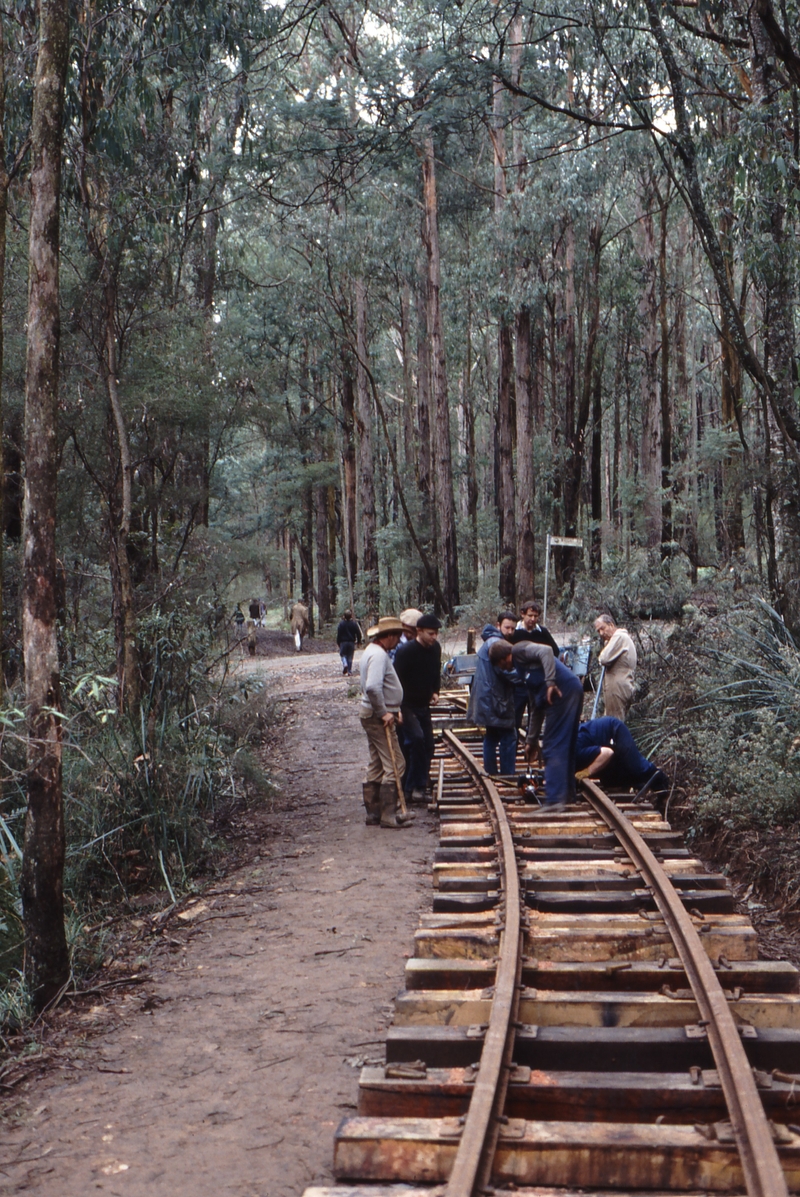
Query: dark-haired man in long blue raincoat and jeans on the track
[[467, 628, 516, 774]]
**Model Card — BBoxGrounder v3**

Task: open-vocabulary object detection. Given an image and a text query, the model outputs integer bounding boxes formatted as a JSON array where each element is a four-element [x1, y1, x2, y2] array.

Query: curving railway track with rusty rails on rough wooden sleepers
[[305, 706, 800, 1197]]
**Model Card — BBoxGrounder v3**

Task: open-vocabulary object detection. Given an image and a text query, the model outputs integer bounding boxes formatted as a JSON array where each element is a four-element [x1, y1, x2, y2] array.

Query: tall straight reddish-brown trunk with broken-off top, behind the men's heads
[[423, 136, 461, 615]]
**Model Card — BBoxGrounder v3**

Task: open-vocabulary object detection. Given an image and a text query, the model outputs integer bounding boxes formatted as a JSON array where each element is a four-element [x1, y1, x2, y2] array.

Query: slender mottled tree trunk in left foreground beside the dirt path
[[20, 0, 69, 1010]]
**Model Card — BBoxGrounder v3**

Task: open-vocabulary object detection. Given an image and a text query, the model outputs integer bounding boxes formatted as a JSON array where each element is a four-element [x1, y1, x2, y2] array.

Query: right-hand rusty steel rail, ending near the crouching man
[[581, 779, 788, 1197]]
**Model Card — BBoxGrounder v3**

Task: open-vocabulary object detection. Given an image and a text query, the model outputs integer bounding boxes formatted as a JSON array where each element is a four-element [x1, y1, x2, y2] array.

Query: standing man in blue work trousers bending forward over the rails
[[510, 642, 583, 814]]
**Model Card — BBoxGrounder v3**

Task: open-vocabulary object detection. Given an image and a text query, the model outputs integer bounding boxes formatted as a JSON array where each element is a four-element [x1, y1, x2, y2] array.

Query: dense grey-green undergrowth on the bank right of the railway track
[[631, 595, 800, 901]]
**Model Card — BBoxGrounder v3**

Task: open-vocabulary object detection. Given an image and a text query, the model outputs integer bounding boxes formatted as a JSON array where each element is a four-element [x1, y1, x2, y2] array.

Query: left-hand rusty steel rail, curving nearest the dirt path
[[442, 730, 522, 1197]]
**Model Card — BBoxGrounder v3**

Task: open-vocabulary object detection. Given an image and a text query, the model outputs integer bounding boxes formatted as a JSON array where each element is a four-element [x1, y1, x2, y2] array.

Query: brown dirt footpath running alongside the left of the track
[[0, 654, 432, 1197]]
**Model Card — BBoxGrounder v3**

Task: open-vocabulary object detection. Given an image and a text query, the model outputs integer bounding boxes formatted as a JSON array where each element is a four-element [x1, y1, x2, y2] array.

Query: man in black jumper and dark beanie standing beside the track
[[394, 612, 442, 802]]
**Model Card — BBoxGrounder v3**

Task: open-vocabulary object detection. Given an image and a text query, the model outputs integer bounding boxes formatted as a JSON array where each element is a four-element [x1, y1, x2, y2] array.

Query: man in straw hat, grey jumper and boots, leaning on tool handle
[[359, 615, 405, 827]]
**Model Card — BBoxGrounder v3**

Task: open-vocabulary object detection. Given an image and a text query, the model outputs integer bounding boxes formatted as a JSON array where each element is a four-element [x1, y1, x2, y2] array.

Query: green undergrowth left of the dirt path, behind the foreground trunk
[[0, 604, 274, 1000]]
